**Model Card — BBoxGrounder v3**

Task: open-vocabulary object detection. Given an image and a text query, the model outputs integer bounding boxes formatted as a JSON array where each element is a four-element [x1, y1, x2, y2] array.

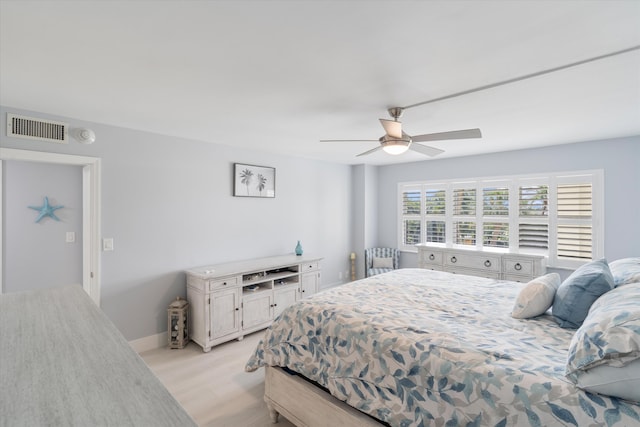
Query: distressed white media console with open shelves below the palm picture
[[186, 255, 322, 352]]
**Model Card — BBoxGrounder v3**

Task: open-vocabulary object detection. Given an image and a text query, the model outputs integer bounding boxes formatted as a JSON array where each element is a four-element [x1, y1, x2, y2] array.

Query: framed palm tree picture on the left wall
[[233, 163, 276, 198]]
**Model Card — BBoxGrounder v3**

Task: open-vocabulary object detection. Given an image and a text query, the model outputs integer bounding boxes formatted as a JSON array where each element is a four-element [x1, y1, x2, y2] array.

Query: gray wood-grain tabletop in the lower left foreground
[[0, 285, 196, 426]]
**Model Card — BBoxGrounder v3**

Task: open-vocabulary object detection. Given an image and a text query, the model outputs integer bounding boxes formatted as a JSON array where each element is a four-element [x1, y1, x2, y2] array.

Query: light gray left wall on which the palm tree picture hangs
[[0, 107, 352, 340]]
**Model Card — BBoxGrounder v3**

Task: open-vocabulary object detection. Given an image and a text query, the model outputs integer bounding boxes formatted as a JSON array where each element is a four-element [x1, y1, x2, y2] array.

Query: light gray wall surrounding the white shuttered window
[[378, 136, 640, 278]]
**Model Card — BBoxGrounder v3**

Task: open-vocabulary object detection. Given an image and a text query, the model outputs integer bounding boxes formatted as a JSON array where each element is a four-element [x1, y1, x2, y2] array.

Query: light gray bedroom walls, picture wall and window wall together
[[0, 101, 640, 340]]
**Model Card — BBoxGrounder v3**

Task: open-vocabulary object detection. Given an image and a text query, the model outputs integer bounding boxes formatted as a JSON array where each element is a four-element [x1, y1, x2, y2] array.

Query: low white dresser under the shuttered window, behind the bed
[[416, 244, 546, 282]]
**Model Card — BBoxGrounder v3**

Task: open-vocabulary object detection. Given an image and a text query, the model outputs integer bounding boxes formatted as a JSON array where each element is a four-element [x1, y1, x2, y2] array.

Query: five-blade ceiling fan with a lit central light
[[320, 107, 482, 157]]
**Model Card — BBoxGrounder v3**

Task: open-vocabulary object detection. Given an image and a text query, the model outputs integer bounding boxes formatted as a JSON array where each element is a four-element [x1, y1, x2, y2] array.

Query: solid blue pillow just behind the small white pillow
[[551, 258, 613, 329]]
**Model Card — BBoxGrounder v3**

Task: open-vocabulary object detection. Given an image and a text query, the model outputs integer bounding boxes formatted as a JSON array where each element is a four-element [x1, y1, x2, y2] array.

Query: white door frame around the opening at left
[[0, 148, 101, 306]]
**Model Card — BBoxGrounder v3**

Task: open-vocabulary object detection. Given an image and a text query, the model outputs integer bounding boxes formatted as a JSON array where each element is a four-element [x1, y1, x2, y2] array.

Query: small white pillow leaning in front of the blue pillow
[[511, 273, 560, 319]]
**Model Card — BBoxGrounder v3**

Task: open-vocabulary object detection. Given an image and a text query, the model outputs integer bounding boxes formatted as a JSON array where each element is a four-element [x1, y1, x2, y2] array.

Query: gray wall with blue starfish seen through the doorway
[[2, 161, 82, 292]]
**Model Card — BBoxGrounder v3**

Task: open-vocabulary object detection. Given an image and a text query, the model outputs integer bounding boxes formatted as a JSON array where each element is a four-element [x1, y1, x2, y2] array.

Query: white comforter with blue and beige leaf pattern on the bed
[[246, 269, 640, 427]]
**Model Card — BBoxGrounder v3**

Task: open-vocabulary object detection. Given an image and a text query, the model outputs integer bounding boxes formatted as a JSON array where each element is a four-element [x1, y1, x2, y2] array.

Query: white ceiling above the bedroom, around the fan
[[0, 0, 640, 164]]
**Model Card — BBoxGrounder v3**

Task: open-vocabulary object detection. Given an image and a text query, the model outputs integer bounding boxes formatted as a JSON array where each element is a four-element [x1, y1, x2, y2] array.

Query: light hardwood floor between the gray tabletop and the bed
[[140, 331, 293, 427]]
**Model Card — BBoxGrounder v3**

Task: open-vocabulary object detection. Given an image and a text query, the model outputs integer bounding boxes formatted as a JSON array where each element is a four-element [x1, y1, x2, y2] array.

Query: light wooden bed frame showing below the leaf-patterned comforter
[[264, 366, 383, 427]]
